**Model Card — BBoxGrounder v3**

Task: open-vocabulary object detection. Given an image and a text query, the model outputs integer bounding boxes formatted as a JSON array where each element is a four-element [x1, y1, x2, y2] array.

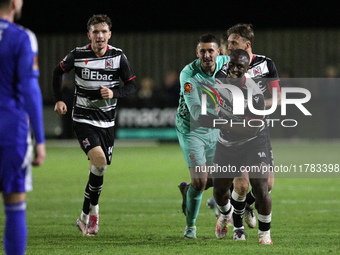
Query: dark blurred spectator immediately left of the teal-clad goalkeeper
[[162, 71, 180, 108]]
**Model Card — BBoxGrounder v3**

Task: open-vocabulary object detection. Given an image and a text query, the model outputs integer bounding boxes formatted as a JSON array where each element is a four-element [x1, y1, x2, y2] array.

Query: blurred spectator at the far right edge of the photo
[[320, 66, 340, 139]]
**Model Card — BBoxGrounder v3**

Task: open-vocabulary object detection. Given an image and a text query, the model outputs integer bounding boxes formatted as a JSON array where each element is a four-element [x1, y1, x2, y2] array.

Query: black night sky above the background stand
[[19, 0, 340, 34]]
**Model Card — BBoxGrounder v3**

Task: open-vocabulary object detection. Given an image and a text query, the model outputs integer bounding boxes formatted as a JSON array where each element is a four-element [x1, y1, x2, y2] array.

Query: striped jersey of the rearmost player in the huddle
[[248, 54, 280, 99]]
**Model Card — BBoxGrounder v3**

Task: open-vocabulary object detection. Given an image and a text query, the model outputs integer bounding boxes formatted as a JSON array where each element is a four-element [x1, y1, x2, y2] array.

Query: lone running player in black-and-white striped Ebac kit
[[53, 14, 136, 235]]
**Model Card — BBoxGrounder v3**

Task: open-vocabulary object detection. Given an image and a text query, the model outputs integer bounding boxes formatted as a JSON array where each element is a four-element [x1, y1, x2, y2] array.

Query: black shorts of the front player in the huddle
[[213, 138, 271, 178]]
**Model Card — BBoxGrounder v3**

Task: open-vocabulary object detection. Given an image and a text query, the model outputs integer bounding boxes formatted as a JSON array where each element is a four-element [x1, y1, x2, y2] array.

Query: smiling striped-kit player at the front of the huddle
[[198, 49, 272, 244]]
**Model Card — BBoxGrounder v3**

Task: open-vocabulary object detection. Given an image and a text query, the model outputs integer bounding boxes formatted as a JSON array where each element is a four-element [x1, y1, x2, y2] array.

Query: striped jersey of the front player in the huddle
[[216, 69, 266, 147]]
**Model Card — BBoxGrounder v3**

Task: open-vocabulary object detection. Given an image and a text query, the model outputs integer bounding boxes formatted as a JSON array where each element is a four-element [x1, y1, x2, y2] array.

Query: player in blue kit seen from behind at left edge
[[0, 0, 45, 254]]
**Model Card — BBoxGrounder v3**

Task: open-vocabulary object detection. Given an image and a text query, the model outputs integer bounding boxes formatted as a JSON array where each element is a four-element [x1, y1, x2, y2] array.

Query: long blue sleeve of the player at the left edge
[[18, 31, 45, 143]]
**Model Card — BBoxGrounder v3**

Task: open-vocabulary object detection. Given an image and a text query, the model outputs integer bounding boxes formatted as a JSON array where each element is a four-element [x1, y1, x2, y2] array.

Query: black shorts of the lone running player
[[73, 122, 114, 165]]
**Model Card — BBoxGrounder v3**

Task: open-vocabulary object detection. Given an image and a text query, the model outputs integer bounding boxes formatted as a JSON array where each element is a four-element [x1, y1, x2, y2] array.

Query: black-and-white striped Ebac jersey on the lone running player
[[60, 44, 136, 128]]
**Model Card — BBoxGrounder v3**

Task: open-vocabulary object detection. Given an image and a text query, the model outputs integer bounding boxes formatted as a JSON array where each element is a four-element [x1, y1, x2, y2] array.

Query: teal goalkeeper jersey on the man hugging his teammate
[[176, 56, 229, 134]]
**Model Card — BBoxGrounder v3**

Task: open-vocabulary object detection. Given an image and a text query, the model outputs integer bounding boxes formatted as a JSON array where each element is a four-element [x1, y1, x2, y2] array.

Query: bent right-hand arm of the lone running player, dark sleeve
[[108, 54, 137, 98]]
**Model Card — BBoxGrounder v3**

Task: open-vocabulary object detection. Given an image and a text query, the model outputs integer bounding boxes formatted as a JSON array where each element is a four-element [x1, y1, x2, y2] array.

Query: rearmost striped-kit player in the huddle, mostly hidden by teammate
[[207, 24, 281, 243]]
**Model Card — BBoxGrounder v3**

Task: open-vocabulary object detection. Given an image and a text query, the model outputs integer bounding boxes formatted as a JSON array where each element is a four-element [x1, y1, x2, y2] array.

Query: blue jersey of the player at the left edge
[[0, 19, 44, 146]]
